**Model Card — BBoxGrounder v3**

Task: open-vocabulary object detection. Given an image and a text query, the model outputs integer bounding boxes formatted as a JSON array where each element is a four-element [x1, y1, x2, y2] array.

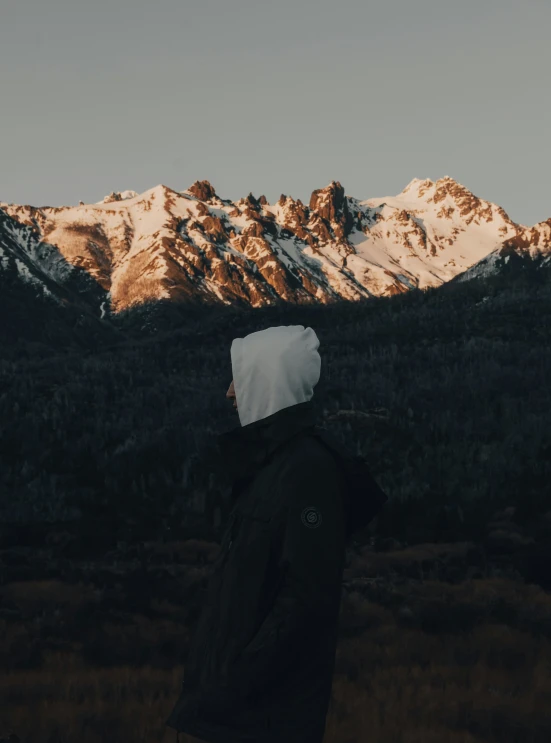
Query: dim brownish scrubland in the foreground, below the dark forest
[[0, 509, 551, 743]]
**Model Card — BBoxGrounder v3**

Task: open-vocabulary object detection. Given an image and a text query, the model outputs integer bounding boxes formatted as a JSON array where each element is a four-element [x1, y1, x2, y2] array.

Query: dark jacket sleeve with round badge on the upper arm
[[223, 448, 345, 696]]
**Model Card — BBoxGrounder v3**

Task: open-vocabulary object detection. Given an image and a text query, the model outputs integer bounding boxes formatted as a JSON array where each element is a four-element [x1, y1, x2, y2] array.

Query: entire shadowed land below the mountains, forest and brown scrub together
[[0, 267, 551, 743]]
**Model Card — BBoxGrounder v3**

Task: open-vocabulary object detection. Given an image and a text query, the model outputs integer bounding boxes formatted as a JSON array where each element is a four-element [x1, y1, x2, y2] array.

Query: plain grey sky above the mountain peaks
[[0, 0, 551, 224]]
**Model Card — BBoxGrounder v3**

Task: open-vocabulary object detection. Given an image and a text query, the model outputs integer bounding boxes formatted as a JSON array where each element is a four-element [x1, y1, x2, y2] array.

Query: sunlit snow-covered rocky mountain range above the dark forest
[[0, 176, 549, 317]]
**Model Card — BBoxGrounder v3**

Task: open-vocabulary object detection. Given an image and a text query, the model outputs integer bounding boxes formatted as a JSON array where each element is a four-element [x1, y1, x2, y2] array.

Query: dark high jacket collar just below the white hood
[[215, 400, 318, 482]]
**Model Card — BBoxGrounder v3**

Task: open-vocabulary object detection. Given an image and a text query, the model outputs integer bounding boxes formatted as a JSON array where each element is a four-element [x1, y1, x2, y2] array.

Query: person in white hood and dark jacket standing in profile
[[166, 325, 387, 743]]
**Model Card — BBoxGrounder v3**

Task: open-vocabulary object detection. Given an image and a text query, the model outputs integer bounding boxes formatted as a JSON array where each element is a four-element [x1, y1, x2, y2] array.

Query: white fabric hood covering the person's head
[[230, 325, 321, 426]]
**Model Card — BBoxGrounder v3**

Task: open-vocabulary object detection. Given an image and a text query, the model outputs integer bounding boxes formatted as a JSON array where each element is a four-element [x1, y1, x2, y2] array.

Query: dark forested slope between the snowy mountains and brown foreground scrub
[[0, 273, 551, 542]]
